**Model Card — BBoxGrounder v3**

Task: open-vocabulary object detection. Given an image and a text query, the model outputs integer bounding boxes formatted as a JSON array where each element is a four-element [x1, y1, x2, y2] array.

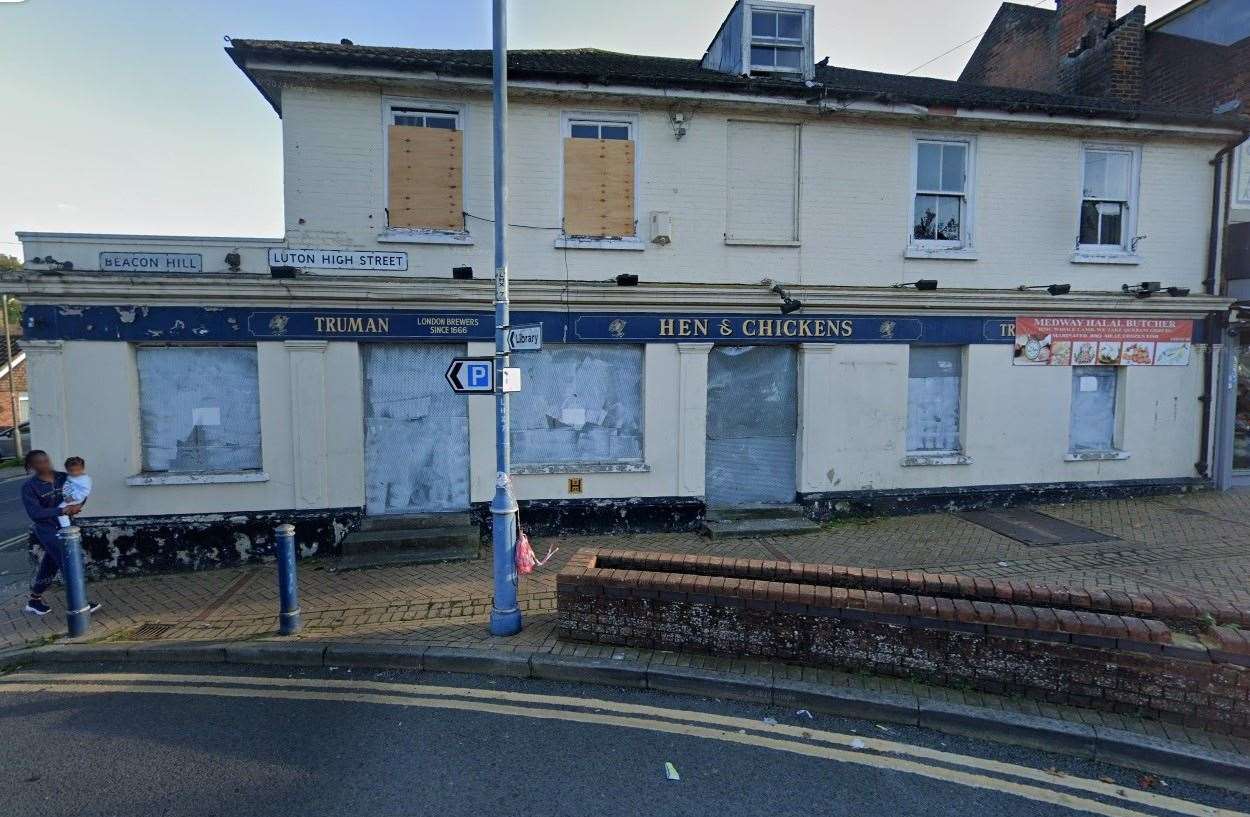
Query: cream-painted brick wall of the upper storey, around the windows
[[283, 86, 1216, 290]]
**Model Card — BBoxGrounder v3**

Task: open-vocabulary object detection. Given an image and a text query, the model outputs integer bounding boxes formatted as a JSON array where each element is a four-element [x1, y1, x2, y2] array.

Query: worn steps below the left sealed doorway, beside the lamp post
[[335, 513, 481, 570]]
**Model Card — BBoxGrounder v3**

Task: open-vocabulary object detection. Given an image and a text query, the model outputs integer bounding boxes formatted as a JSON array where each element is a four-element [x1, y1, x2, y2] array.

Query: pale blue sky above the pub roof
[[0, 0, 1185, 255]]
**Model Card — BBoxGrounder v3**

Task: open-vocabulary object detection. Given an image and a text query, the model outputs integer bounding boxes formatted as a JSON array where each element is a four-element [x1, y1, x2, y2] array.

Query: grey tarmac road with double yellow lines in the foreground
[[0, 665, 1250, 817]]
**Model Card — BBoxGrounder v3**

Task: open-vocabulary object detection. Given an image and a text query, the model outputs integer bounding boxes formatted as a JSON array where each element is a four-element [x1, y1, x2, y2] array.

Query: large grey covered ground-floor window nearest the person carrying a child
[[136, 346, 261, 473]]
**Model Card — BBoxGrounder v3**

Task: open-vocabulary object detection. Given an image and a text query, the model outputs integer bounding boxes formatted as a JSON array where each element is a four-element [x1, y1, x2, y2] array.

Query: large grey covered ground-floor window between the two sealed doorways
[[511, 344, 644, 466]]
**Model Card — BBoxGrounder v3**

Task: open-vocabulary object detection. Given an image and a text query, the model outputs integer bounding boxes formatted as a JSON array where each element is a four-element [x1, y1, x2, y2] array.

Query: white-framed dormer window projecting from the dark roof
[[703, 0, 816, 80]]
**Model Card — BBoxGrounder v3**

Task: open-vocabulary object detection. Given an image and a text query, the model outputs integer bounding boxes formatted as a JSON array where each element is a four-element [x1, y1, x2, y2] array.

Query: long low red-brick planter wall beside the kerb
[[556, 548, 1250, 736]]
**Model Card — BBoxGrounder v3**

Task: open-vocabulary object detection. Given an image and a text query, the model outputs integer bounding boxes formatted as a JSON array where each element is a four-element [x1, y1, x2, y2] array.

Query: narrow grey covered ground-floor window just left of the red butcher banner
[[908, 346, 964, 453]]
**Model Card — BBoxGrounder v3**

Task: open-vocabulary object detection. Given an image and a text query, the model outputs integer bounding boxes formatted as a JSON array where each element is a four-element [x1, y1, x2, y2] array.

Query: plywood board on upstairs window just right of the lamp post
[[564, 139, 635, 236]]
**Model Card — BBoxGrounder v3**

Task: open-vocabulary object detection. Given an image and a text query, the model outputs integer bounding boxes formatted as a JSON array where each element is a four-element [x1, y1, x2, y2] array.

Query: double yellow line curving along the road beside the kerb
[[0, 672, 1250, 817]]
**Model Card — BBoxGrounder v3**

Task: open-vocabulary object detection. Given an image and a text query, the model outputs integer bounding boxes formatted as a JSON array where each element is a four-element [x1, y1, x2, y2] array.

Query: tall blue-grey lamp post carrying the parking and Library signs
[[490, 0, 521, 636]]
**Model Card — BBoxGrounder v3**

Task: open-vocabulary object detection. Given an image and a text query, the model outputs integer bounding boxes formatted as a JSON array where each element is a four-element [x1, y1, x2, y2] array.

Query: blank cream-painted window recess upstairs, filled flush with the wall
[[725, 121, 799, 242]]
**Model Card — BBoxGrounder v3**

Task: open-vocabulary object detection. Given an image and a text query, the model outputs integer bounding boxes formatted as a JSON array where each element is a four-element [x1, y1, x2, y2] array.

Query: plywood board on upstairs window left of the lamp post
[[386, 125, 464, 230]]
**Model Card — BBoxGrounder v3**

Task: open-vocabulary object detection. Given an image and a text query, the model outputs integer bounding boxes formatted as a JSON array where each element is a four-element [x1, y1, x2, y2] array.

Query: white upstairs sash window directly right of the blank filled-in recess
[[911, 139, 973, 249]]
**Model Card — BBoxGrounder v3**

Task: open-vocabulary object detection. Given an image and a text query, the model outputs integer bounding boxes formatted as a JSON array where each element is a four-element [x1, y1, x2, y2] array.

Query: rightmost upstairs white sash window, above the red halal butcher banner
[[1078, 147, 1138, 252]]
